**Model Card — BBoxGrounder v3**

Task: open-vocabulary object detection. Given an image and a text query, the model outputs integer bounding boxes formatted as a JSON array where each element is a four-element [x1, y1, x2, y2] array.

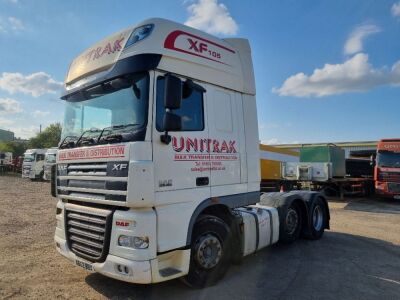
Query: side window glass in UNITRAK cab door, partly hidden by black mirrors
[[156, 76, 204, 132]]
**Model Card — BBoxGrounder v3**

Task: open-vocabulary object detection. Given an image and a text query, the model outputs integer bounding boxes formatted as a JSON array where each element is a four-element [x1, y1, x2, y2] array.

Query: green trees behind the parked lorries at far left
[[0, 123, 61, 157]]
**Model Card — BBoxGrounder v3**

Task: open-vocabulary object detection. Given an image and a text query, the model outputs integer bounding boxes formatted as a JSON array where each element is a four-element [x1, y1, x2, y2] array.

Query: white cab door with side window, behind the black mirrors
[[153, 72, 210, 195]]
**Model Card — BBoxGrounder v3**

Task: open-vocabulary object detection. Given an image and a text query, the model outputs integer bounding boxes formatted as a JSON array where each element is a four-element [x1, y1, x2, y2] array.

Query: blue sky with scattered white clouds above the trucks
[[0, 0, 400, 143]]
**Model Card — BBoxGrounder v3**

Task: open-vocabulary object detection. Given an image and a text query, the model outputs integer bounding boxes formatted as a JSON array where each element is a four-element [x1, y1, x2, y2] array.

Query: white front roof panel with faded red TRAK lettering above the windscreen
[[65, 29, 132, 85]]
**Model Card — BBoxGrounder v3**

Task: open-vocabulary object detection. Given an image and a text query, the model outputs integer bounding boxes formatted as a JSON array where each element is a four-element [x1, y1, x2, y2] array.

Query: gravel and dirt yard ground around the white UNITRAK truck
[[0, 176, 400, 299]]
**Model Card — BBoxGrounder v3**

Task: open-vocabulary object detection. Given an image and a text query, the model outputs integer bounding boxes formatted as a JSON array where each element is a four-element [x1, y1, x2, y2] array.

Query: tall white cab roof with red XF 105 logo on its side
[[65, 18, 255, 95]]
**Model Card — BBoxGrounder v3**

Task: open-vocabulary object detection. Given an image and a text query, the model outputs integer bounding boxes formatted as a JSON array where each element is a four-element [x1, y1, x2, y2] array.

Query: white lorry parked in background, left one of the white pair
[[22, 149, 47, 180]]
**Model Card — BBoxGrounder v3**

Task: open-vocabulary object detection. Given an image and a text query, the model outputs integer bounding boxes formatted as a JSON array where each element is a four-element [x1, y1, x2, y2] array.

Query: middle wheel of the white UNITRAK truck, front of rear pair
[[279, 202, 303, 244]]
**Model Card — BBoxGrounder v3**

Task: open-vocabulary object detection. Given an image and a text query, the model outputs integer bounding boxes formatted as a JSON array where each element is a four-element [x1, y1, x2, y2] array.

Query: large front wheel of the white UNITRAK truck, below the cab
[[182, 215, 232, 288]]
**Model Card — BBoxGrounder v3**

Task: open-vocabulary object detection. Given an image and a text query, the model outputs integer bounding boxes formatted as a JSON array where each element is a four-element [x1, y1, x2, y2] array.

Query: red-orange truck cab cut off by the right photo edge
[[374, 139, 400, 199]]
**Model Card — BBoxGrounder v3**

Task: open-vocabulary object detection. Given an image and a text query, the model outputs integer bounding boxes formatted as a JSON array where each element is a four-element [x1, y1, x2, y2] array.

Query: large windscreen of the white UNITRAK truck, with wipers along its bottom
[[60, 73, 149, 147]]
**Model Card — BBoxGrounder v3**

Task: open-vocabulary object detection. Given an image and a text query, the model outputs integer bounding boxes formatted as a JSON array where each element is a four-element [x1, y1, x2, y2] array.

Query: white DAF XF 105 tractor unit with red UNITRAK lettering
[[52, 19, 329, 287]]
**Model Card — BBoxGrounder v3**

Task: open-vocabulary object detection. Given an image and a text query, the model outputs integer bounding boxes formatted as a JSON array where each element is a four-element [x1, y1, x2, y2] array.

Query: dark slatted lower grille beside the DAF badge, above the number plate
[[65, 208, 112, 262]]
